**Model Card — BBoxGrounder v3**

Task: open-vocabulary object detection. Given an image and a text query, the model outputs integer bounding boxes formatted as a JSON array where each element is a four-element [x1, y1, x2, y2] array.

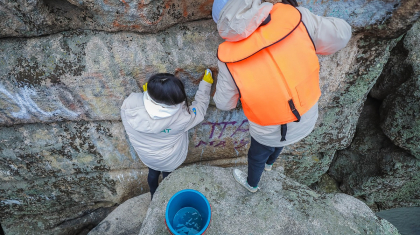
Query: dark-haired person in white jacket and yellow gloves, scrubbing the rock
[[121, 69, 213, 199]]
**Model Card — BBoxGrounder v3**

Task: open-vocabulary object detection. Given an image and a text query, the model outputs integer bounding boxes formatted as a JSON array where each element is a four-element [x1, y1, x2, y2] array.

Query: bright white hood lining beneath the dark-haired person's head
[[143, 91, 183, 119]]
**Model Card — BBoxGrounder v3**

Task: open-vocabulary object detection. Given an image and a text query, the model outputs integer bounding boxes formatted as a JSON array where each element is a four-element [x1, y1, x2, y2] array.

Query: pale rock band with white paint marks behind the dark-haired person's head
[[0, 21, 221, 125]]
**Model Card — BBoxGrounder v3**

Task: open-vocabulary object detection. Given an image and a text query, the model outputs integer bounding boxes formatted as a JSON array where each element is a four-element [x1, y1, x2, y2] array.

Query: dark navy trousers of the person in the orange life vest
[[247, 137, 283, 187]]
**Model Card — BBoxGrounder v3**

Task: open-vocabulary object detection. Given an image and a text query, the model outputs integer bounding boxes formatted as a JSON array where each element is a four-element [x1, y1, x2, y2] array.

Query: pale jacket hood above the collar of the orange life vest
[[217, 0, 273, 42]]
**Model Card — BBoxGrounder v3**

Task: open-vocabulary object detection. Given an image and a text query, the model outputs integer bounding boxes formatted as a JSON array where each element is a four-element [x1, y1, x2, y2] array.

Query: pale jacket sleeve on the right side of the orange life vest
[[297, 7, 351, 55]]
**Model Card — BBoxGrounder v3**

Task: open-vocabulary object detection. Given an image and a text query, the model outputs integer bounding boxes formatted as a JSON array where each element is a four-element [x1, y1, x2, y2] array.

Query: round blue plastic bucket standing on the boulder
[[165, 189, 211, 235]]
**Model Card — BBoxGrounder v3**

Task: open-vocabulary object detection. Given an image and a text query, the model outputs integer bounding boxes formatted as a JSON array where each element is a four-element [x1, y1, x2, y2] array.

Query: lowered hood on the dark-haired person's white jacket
[[121, 92, 181, 133]]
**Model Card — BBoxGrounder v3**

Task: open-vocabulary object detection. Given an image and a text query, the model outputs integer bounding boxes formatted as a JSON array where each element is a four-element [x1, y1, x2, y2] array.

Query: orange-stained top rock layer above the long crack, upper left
[[0, 0, 213, 37]]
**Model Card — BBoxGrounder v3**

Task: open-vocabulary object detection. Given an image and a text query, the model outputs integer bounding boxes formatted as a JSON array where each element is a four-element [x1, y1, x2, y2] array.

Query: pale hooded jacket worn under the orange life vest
[[213, 0, 351, 147]]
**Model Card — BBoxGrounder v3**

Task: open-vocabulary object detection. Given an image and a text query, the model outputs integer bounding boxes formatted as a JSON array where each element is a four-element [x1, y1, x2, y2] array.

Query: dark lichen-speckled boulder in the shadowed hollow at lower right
[[329, 147, 420, 211]]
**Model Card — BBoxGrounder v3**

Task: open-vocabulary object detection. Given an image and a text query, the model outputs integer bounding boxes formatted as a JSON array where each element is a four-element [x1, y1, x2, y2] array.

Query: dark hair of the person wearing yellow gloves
[[147, 73, 190, 112]]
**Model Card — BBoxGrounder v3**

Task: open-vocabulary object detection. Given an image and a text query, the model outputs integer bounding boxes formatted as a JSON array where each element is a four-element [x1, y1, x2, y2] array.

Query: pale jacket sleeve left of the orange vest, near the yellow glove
[[213, 60, 239, 110]]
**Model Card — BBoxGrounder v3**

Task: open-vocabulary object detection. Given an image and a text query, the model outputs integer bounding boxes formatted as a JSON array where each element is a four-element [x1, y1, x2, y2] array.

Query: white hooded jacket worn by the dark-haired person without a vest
[[121, 81, 211, 172]]
